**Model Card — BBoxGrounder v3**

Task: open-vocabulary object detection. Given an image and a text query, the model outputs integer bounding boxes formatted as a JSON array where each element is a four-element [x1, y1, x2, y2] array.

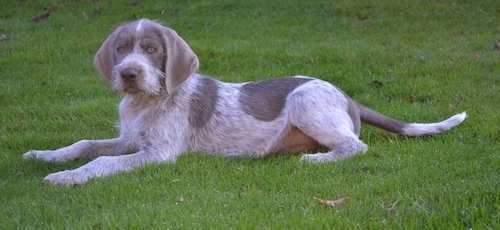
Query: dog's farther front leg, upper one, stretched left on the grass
[[23, 138, 136, 162]]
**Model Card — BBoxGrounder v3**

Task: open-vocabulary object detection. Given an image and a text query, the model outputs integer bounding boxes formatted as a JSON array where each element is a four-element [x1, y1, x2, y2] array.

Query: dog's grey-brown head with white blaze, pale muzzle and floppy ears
[[94, 19, 199, 95]]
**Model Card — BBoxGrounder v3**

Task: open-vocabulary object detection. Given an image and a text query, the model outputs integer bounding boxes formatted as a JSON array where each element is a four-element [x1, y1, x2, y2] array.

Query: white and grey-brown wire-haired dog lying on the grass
[[23, 19, 466, 185]]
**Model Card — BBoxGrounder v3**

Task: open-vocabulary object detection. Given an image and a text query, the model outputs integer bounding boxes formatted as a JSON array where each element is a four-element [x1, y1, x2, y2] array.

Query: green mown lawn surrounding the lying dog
[[0, 0, 500, 229]]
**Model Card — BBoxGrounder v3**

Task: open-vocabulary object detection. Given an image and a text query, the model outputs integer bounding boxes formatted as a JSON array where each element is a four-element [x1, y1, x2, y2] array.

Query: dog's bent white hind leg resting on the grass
[[287, 87, 368, 163]]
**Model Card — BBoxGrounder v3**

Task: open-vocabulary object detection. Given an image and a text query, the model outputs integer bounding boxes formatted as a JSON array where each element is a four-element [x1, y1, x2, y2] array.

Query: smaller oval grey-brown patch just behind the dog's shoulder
[[188, 77, 219, 128]]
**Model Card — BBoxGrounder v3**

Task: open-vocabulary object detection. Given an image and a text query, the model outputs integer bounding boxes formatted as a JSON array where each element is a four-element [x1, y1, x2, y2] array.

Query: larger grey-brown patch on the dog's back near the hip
[[238, 77, 314, 121]]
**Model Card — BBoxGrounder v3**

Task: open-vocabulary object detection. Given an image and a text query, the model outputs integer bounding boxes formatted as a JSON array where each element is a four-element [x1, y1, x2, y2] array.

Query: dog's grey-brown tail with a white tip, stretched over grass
[[359, 105, 467, 136]]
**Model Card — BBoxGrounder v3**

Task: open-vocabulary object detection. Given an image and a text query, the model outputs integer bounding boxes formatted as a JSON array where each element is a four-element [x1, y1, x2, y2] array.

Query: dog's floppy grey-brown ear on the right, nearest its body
[[162, 27, 199, 94]]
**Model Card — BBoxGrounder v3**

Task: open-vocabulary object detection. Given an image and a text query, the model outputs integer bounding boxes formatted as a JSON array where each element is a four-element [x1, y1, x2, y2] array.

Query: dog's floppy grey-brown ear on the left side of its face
[[94, 29, 118, 81]]
